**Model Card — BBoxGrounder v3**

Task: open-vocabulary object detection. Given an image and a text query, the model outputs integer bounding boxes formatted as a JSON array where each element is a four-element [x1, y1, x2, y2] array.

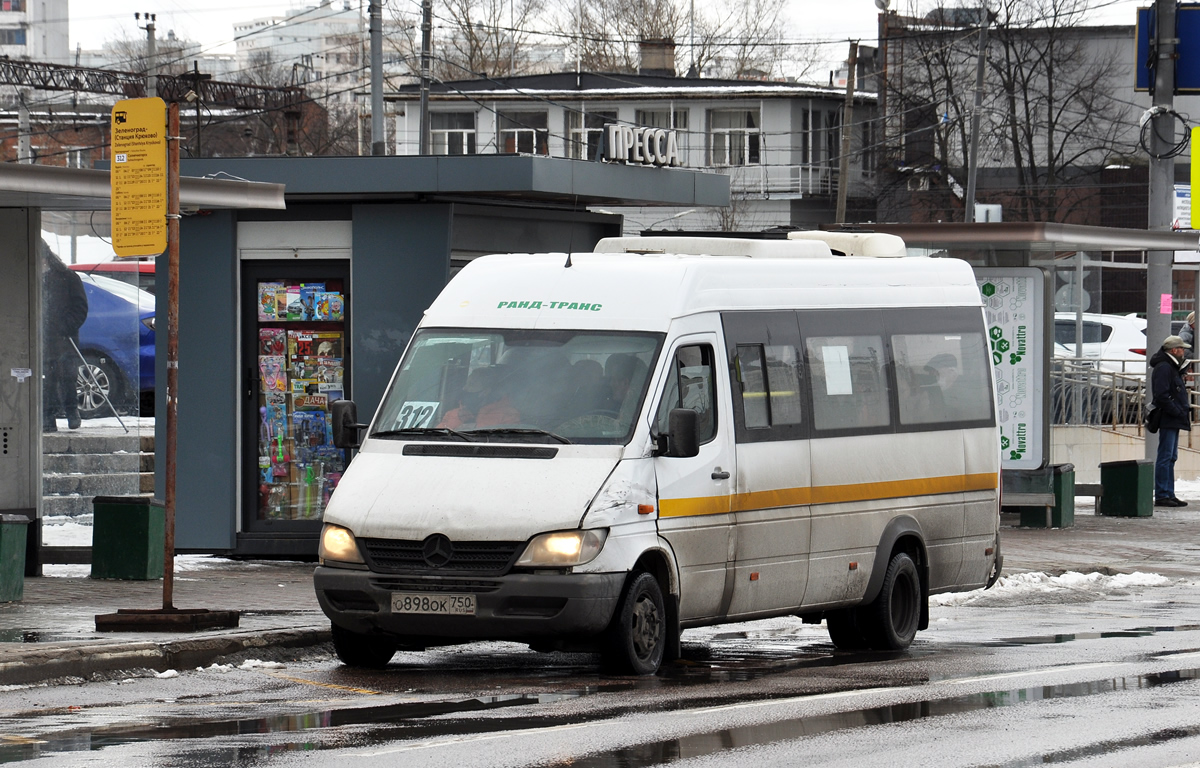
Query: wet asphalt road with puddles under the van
[[0, 577, 1200, 768]]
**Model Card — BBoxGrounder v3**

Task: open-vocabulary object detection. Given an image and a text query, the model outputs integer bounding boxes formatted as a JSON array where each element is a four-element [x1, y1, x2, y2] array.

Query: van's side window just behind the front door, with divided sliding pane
[[737, 344, 804, 430]]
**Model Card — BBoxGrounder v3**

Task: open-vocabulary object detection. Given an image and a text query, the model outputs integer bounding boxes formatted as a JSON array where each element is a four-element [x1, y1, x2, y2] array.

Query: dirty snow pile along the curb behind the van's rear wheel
[[929, 571, 1171, 606]]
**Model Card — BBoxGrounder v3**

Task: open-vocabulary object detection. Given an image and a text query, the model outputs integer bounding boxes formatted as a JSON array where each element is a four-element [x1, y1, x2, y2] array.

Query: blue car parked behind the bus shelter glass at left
[[77, 274, 155, 419]]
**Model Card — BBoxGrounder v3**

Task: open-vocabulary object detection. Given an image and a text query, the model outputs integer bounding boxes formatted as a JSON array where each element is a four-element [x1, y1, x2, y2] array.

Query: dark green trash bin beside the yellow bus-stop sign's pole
[[91, 496, 167, 581]]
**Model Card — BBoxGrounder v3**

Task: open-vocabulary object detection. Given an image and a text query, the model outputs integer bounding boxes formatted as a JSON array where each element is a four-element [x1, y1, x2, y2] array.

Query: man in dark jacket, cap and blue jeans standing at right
[[1150, 336, 1192, 506]]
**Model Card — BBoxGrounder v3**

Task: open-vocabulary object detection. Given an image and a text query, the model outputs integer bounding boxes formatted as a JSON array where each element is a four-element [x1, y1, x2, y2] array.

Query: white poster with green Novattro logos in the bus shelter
[[974, 266, 1046, 469]]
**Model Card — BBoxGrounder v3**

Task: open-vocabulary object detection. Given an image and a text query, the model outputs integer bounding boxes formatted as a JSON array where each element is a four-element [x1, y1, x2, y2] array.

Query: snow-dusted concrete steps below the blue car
[[42, 430, 154, 517]]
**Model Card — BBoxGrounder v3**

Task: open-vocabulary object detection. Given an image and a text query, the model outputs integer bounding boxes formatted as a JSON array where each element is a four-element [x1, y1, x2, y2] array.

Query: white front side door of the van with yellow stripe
[[654, 334, 737, 620]]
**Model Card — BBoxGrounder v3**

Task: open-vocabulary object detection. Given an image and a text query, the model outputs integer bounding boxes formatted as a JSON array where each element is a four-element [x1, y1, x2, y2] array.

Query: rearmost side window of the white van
[[892, 334, 991, 425]]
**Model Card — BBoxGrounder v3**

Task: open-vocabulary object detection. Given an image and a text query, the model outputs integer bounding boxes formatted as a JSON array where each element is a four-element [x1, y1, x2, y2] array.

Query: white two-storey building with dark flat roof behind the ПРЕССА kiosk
[[388, 67, 876, 232]]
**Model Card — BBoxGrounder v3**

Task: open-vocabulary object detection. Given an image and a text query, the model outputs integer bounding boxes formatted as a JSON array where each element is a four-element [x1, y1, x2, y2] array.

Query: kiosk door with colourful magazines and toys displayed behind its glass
[[241, 260, 350, 537]]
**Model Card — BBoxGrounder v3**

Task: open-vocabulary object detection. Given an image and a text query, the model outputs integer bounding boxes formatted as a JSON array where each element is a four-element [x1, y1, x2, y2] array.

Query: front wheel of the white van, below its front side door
[[606, 572, 667, 674]]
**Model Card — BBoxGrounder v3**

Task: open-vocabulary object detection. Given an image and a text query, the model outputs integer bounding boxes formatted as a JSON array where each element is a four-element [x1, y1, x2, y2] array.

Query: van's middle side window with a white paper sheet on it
[[805, 336, 892, 430]]
